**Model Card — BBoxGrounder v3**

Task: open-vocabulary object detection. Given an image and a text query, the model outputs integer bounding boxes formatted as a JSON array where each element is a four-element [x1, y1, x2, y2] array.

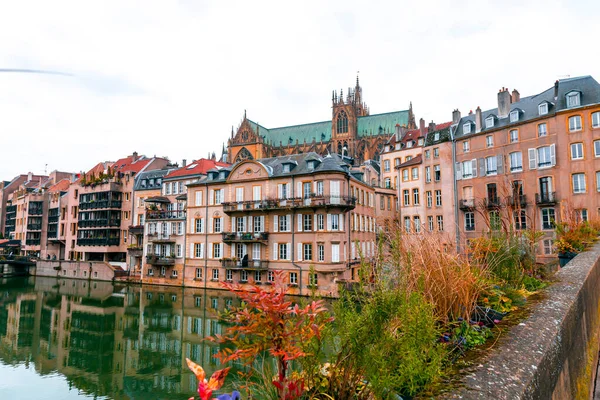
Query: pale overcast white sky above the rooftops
[[0, 0, 600, 180]]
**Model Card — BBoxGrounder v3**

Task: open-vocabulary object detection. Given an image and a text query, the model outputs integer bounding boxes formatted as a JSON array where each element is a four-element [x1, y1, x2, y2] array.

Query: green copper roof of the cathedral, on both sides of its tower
[[248, 111, 408, 146]]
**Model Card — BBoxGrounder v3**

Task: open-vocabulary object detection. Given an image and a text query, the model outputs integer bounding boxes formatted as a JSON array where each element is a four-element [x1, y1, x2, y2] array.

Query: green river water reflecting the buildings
[[0, 277, 278, 400]]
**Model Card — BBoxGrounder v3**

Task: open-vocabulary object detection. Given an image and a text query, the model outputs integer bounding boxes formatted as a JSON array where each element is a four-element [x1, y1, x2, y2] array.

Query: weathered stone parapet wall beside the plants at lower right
[[441, 244, 600, 399]]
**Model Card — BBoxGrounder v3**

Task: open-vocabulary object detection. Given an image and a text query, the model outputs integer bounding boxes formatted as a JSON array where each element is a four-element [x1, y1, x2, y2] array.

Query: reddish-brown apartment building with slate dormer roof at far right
[[453, 76, 600, 261]]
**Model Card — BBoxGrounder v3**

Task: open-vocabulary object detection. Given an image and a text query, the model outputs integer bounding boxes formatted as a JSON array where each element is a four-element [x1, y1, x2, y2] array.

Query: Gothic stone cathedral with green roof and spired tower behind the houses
[[223, 77, 416, 164]]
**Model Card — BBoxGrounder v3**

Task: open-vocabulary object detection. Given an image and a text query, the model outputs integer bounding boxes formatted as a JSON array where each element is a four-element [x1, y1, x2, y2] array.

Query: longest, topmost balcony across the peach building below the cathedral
[[222, 195, 356, 213]]
